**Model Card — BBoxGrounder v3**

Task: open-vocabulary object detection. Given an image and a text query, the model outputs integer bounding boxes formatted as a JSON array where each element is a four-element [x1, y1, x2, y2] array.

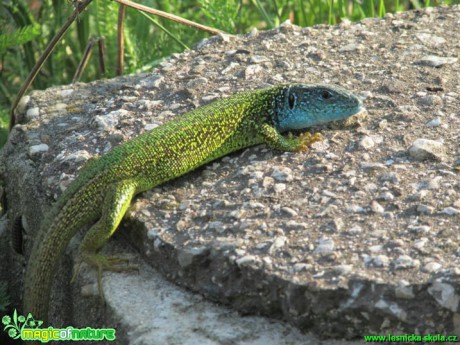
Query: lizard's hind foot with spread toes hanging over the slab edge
[[70, 254, 139, 301]]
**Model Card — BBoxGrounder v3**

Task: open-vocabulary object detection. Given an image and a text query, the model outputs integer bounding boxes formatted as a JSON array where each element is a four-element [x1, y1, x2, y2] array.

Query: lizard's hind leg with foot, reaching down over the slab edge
[[72, 180, 138, 300]]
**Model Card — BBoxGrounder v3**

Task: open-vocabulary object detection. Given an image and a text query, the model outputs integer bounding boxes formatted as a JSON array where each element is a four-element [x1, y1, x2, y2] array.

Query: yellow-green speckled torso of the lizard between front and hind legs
[[111, 85, 279, 191]]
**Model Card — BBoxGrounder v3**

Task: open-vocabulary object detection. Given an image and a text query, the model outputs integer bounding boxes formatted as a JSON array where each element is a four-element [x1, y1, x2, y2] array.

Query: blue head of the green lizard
[[274, 84, 364, 132]]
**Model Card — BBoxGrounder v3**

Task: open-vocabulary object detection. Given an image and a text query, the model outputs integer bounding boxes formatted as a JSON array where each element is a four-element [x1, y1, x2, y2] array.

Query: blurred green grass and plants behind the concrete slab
[[0, 0, 460, 145]]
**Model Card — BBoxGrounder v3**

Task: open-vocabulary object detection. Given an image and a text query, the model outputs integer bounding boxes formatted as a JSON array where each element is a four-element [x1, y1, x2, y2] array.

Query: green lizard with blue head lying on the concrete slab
[[24, 84, 364, 320]]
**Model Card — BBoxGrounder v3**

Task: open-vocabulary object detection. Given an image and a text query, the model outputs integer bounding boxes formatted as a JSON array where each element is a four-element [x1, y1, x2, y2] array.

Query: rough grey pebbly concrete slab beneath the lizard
[[2, 6, 460, 344]]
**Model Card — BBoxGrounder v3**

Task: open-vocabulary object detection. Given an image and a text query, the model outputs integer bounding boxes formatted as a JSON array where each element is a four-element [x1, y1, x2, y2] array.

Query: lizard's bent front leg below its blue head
[[260, 123, 322, 152]]
